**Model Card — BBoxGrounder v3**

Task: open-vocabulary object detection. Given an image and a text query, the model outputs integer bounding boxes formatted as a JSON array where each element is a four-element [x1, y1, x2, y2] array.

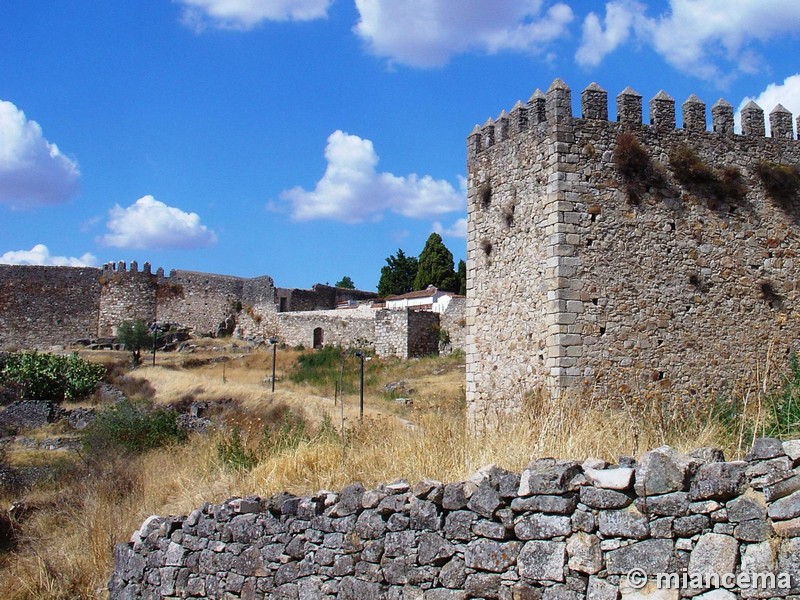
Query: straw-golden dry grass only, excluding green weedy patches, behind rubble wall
[[0, 352, 788, 600]]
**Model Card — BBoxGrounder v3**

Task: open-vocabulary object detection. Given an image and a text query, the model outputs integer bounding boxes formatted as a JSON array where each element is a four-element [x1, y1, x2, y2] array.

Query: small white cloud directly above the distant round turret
[[97, 195, 217, 250]]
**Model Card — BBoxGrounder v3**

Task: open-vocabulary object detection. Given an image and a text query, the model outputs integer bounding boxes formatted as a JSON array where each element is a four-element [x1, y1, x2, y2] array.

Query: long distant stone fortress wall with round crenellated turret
[[0, 261, 456, 358]]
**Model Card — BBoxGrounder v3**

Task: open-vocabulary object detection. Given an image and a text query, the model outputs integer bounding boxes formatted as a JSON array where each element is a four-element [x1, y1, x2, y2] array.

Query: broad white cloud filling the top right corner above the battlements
[[576, 0, 800, 85]]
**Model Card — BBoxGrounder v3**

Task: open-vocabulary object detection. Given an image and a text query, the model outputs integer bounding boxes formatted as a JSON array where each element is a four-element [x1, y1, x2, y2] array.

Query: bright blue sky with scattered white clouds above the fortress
[[0, 0, 800, 289]]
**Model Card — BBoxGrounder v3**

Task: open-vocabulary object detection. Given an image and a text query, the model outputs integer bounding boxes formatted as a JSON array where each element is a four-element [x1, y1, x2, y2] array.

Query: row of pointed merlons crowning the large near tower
[[467, 79, 800, 161]]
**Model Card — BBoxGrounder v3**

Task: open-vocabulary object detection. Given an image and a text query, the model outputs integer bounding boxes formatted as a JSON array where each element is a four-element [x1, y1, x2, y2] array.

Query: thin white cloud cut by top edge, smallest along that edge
[[176, 0, 331, 31]]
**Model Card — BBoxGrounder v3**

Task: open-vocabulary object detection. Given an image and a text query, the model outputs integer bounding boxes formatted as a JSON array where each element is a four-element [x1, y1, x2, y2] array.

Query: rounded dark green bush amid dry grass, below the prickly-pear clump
[[83, 400, 186, 457]]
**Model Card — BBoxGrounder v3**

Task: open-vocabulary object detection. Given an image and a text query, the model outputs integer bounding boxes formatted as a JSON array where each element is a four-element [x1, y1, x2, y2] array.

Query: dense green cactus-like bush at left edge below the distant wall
[[0, 351, 105, 402]]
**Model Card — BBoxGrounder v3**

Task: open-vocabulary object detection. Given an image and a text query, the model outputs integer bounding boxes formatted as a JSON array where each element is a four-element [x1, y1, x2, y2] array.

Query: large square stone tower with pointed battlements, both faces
[[466, 80, 800, 426]]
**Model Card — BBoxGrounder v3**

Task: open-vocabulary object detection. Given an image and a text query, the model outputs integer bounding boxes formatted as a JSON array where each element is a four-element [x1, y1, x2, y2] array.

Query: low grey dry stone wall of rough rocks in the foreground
[[109, 438, 800, 600]]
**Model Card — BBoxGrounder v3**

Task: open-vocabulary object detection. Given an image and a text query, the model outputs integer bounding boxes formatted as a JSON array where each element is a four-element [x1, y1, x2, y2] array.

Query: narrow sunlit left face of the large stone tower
[[466, 103, 565, 422]]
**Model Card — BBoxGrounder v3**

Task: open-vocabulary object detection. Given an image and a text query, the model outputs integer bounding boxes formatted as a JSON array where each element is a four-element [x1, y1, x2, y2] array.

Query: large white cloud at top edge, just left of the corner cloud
[[355, 0, 573, 67]]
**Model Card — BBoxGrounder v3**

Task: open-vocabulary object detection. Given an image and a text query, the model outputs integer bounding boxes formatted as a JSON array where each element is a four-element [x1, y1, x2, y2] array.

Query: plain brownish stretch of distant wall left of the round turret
[[0, 265, 100, 349]]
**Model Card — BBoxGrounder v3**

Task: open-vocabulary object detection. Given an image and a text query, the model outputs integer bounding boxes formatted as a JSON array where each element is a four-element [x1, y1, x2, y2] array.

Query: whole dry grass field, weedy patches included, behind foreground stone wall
[[0, 345, 792, 600]]
